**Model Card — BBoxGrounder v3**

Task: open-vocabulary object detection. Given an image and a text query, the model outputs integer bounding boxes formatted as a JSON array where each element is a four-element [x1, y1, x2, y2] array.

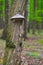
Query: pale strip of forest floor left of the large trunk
[[0, 39, 6, 65]]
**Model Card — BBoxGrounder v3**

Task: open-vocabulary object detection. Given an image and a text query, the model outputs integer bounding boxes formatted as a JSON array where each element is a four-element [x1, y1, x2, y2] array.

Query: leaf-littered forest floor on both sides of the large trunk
[[0, 32, 43, 65]]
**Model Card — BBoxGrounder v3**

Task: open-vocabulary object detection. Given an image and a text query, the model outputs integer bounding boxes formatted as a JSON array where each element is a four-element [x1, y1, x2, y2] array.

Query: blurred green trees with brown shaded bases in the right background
[[29, 0, 43, 33]]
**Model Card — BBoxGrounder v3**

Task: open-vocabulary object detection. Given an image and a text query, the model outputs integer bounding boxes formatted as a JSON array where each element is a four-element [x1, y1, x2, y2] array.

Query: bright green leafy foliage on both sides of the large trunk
[[0, 0, 43, 21]]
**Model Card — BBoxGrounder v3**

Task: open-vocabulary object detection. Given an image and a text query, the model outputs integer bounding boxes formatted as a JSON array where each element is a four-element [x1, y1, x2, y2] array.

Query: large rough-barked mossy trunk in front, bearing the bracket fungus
[[4, 0, 25, 65]]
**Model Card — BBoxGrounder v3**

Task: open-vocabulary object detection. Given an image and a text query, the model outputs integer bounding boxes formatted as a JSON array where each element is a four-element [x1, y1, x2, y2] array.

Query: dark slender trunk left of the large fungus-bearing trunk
[[3, 0, 10, 39]]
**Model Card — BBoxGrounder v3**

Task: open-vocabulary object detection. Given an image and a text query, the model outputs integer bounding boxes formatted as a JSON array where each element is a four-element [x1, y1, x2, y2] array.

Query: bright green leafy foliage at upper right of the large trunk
[[29, 0, 43, 22]]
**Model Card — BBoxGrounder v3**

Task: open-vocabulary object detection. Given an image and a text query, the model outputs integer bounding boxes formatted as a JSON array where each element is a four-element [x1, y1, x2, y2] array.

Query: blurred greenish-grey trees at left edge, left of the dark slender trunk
[[0, 0, 5, 29]]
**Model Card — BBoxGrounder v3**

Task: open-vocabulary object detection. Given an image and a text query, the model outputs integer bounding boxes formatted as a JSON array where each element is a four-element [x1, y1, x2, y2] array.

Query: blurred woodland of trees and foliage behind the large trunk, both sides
[[0, 0, 43, 38]]
